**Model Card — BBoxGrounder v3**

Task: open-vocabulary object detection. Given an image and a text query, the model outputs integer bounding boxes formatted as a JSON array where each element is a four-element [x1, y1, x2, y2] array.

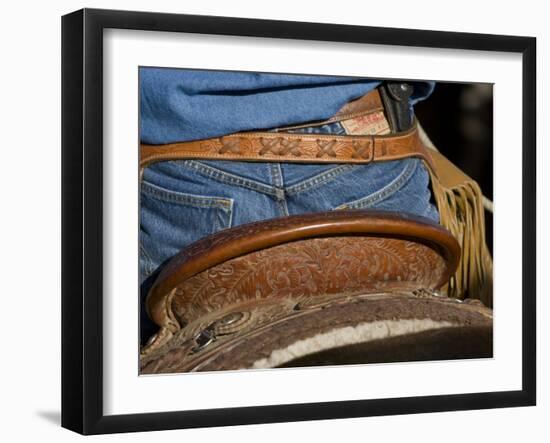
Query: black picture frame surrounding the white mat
[[62, 9, 536, 434]]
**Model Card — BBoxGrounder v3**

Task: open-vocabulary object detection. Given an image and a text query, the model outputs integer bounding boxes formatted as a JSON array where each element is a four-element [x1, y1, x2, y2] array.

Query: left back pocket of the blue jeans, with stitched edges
[[139, 181, 233, 281]]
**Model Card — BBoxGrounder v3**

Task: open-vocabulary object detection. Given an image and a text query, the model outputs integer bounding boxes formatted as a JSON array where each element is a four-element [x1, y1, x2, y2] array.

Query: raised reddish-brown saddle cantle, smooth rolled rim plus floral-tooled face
[[142, 210, 460, 362]]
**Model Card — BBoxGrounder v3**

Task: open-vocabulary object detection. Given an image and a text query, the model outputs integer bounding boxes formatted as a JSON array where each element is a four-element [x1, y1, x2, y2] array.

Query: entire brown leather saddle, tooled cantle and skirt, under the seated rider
[[140, 210, 492, 374]]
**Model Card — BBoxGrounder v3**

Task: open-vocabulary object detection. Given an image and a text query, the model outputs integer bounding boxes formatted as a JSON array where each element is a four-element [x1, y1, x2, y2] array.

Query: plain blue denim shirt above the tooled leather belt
[[139, 67, 434, 144]]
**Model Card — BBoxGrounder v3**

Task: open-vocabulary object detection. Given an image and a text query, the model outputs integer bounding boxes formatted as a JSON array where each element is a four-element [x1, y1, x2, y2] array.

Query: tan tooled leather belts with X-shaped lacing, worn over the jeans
[[140, 90, 434, 173]]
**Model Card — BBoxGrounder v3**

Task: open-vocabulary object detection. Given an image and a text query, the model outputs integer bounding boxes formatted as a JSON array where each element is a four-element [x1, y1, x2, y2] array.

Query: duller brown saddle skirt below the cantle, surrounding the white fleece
[[140, 291, 492, 374]]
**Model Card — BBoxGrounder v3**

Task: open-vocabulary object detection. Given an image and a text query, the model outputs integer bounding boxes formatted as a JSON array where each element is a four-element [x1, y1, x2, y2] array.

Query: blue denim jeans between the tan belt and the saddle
[[139, 119, 439, 342]]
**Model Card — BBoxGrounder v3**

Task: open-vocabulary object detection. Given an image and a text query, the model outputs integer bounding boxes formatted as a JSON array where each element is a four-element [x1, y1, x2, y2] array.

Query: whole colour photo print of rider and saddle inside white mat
[[136, 66, 493, 375]]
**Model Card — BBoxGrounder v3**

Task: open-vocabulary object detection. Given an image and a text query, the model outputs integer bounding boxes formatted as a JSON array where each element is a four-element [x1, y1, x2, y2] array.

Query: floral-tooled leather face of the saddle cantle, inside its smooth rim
[[171, 236, 449, 325]]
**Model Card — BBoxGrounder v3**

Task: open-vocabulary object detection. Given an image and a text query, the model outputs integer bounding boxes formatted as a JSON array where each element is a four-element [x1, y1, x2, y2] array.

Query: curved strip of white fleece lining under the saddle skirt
[[252, 319, 460, 369]]
